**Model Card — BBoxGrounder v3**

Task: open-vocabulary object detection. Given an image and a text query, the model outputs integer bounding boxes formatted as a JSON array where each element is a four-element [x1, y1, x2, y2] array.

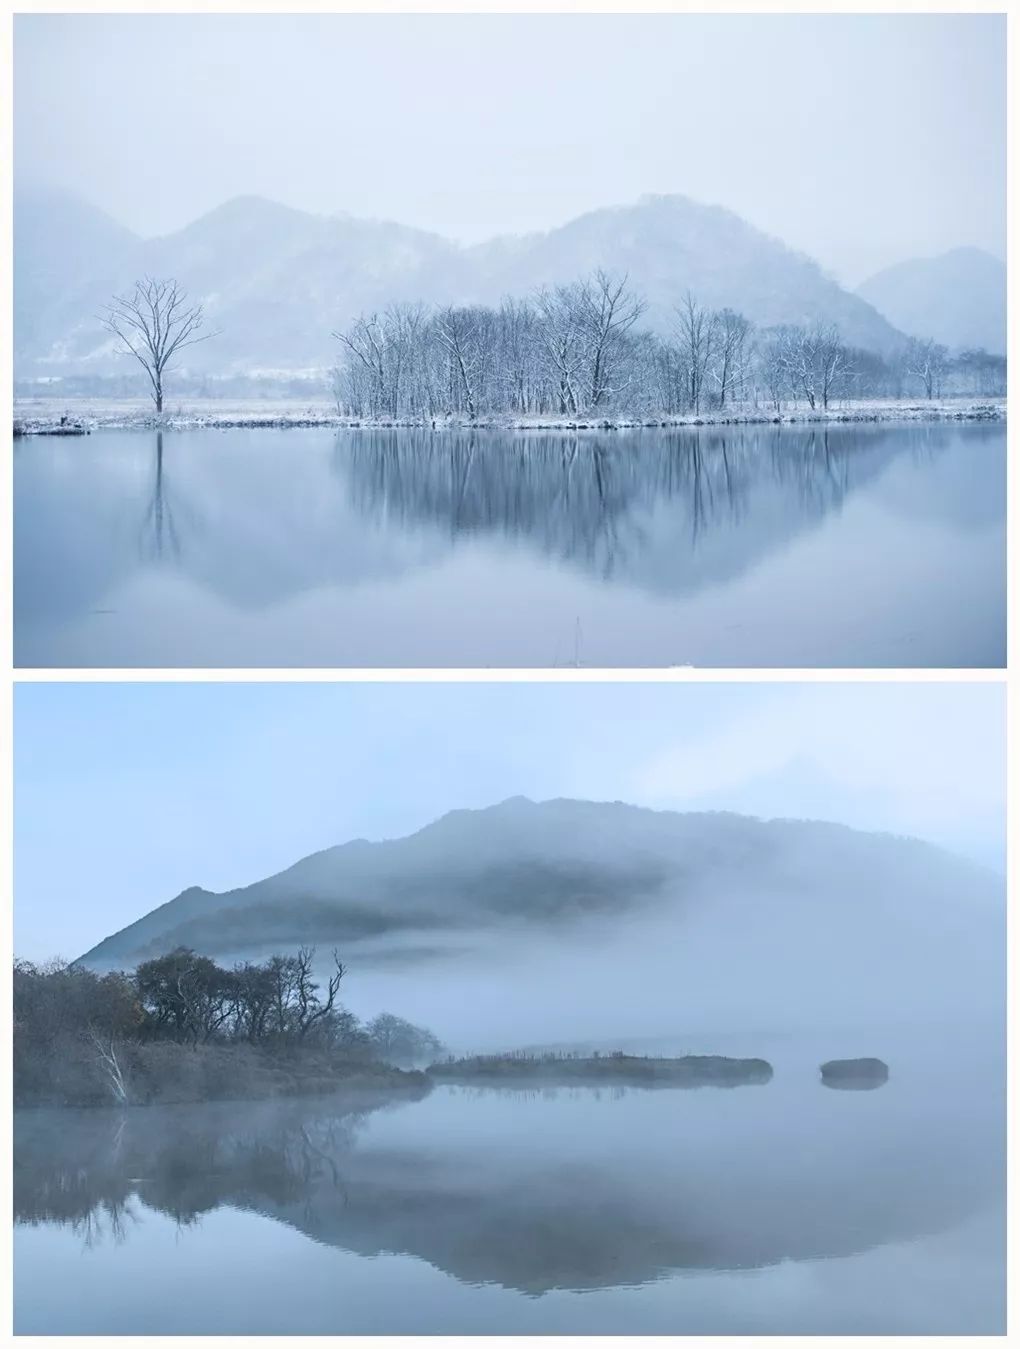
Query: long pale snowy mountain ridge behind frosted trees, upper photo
[[15, 192, 901, 378]]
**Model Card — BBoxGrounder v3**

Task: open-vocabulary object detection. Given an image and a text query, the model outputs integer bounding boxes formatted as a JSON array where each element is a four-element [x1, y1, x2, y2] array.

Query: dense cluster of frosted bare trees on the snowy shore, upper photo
[[333, 290, 855, 420]]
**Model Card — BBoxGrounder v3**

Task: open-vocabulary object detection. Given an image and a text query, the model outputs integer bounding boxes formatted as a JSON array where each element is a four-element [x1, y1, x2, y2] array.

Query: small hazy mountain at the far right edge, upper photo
[[857, 248, 1007, 355]]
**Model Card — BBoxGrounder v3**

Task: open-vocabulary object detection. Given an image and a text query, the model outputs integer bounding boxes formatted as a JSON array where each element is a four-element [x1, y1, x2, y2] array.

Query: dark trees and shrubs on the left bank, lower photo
[[13, 947, 443, 1102]]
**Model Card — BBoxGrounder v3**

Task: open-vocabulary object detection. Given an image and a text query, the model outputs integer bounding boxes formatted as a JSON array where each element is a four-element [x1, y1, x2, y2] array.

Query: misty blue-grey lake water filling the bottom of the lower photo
[[13, 1036, 1005, 1334]]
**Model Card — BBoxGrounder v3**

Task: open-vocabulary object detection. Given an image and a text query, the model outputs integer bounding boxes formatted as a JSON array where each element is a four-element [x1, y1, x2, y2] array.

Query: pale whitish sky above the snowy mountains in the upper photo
[[15, 15, 1005, 283]]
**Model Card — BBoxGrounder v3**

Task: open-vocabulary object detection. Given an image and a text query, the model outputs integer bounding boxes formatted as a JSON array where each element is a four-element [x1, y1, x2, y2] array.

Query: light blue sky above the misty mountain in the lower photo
[[15, 683, 1005, 959]]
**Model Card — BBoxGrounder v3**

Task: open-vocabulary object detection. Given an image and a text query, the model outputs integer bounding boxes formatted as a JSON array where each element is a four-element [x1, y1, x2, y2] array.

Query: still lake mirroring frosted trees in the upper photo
[[15, 424, 1005, 666]]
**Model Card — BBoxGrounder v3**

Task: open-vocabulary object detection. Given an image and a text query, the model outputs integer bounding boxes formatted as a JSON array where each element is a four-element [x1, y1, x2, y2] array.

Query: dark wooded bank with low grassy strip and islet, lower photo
[[13, 947, 906, 1109]]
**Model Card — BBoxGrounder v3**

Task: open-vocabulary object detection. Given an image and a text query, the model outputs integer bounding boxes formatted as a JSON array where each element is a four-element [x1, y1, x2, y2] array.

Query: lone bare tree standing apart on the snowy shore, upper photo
[[100, 277, 216, 413]]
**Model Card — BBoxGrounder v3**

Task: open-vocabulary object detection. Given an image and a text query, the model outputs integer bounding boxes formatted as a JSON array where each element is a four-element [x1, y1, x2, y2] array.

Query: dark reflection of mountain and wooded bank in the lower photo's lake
[[13, 1087, 1001, 1294]]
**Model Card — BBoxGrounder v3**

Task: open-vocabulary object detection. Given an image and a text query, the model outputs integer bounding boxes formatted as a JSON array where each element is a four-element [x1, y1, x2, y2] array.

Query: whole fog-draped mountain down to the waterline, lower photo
[[82, 797, 1002, 1043]]
